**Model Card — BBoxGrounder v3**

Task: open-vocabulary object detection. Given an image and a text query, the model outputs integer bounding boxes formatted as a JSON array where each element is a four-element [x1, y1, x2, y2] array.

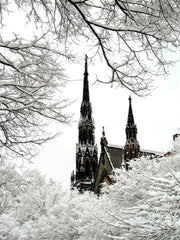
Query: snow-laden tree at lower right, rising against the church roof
[[79, 140, 180, 240]]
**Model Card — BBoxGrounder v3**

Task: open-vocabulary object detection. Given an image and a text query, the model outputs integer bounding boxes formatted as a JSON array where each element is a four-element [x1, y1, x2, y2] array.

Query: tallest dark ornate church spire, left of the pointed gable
[[71, 55, 98, 192]]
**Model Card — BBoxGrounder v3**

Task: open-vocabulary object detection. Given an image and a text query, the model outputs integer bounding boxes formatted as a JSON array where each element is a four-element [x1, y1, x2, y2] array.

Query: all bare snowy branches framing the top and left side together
[[0, 0, 180, 159]]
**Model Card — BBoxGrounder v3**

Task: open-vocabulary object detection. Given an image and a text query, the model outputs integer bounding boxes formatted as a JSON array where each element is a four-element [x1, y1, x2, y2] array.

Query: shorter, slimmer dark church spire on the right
[[124, 96, 140, 170]]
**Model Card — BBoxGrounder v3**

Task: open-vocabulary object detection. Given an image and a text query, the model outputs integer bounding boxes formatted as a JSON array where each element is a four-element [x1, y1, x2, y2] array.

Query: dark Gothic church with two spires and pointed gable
[[71, 56, 158, 194]]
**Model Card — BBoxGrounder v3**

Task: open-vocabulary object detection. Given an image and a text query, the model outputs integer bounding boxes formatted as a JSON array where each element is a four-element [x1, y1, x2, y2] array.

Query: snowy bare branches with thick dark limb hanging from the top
[[1, 0, 180, 94]]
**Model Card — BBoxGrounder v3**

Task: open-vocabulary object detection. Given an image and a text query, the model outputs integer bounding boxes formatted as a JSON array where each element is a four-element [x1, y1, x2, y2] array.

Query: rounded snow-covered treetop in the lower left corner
[[0, 163, 78, 240]]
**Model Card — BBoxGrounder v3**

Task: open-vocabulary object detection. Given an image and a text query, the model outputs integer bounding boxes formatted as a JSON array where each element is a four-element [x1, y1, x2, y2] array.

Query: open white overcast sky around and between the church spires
[[33, 56, 180, 187]]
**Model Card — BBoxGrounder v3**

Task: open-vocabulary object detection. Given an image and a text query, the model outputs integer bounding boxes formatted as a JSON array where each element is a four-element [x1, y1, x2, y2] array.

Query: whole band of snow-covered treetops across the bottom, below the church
[[0, 139, 180, 240]]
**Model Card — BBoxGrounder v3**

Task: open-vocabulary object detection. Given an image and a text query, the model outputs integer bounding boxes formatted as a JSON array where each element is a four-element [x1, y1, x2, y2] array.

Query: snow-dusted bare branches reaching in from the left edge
[[0, 1, 70, 159]]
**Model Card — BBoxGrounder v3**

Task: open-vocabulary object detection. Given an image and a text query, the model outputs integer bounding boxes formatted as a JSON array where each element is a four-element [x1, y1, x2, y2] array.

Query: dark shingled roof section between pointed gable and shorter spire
[[106, 146, 124, 168]]
